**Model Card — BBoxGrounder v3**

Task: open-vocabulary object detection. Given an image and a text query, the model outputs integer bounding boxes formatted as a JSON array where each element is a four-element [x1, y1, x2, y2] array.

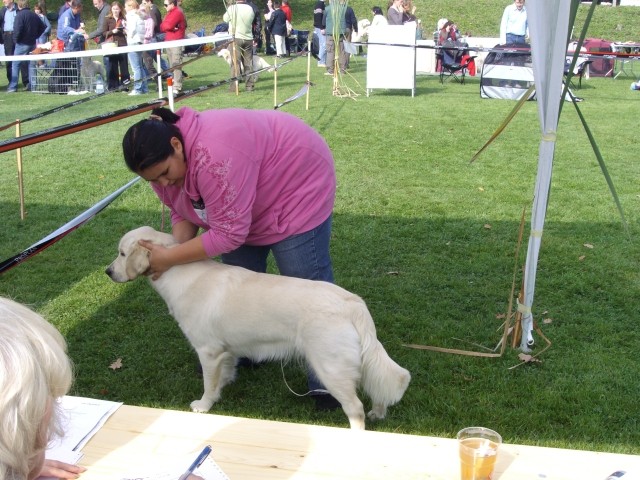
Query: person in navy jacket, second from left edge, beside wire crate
[[7, 0, 46, 93]]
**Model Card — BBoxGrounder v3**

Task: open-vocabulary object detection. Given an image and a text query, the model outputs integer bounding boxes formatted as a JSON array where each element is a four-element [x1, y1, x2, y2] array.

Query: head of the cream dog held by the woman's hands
[[105, 227, 176, 283]]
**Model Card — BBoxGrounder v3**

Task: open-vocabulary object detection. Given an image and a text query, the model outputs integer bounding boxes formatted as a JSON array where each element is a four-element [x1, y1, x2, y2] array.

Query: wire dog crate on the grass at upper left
[[31, 57, 96, 94]]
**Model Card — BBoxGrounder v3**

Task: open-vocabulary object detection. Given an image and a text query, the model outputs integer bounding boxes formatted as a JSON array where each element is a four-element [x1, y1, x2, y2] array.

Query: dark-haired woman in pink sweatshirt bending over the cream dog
[[122, 107, 339, 410]]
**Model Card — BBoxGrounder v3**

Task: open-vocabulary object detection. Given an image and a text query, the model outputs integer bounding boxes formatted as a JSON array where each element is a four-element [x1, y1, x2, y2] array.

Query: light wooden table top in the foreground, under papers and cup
[[80, 405, 640, 480]]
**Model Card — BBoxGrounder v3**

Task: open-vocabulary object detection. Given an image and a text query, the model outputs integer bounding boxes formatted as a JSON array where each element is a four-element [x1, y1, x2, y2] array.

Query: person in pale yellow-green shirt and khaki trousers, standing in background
[[222, 0, 255, 93]]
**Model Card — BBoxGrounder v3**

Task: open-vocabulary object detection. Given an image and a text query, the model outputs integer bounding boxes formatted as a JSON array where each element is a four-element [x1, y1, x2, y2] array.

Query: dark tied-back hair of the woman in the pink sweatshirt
[[122, 108, 184, 173]]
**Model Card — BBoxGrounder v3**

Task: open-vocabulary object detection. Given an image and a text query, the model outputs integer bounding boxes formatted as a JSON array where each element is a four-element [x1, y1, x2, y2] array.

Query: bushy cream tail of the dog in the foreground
[[352, 302, 411, 408]]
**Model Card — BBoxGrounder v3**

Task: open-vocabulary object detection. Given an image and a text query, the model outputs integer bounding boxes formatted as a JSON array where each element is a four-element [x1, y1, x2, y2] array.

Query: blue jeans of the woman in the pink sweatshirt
[[221, 216, 333, 393]]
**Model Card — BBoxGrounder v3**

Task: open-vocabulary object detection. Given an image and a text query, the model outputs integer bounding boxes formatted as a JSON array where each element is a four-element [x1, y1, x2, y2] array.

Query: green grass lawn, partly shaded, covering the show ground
[[0, 0, 640, 454]]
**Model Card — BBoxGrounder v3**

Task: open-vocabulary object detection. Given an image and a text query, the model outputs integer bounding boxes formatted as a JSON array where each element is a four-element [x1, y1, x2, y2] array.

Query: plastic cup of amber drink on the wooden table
[[458, 427, 502, 480]]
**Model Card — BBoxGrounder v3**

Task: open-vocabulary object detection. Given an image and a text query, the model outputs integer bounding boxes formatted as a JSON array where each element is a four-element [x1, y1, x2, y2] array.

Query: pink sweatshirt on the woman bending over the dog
[[152, 107, 336, 257]]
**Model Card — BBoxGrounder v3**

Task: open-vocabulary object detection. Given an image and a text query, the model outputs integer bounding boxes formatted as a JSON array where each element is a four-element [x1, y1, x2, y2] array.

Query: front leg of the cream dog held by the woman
[[191, 350, 236, 412]]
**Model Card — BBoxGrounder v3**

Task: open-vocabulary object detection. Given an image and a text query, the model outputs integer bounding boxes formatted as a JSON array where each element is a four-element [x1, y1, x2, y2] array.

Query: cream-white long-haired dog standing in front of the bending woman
[[106, 227, 411, 429]]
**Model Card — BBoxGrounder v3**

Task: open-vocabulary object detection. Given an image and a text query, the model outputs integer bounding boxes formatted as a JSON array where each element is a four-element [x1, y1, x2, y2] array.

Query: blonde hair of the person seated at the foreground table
[[0, 297, 73, 479]]
